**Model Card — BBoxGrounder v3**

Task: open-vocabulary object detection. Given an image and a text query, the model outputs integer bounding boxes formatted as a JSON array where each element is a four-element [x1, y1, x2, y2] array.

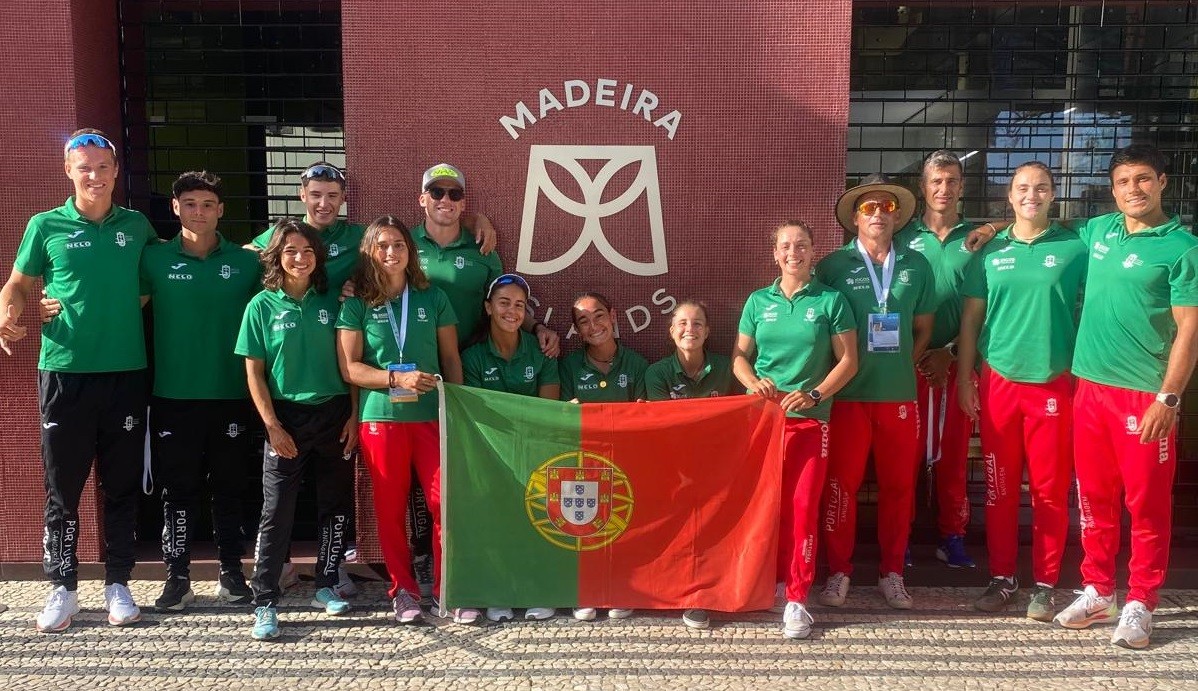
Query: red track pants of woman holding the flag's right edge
[[778, 418, 828, 604]]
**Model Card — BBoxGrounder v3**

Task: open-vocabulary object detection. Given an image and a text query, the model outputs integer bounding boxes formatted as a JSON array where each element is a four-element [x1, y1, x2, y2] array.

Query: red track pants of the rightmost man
[[1073, 380, 1178, 610]]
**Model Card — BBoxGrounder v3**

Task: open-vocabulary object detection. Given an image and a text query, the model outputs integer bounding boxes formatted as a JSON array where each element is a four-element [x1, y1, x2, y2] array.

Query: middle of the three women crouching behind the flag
[[558, 292, 649, 622]]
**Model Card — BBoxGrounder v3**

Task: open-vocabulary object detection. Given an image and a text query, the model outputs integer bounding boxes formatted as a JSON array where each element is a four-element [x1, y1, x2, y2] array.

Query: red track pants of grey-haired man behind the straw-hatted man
[[915, 363, 973, 538]]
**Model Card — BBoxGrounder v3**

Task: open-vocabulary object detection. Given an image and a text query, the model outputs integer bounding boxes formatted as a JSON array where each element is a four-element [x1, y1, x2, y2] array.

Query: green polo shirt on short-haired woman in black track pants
[[234, 286, 350, 405]]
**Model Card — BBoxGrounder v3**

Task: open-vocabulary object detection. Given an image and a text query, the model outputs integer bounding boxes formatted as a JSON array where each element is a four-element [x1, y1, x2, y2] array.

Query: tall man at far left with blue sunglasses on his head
[[0, 129, 158, 632]]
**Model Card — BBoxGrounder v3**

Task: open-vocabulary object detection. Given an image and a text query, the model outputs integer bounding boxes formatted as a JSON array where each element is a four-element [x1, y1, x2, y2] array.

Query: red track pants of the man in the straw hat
[[823, 401, 919, 575]]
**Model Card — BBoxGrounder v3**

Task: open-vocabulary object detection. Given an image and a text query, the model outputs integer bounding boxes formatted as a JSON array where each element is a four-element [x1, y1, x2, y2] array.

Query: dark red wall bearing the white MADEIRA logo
[[341, 0, 852, 560]]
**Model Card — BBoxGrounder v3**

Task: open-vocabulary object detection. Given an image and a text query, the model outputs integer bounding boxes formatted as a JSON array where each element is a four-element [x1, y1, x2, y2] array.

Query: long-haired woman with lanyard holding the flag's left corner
[[337, 216, 467, 624]]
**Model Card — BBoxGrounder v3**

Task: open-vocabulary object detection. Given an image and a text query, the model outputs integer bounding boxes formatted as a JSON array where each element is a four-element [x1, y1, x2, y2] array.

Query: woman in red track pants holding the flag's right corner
[[732, 220, 857, 638]]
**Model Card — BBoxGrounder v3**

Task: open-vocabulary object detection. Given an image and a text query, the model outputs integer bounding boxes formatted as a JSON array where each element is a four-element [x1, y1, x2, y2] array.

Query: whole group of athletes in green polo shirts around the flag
[[0, 129, 1198, 648]]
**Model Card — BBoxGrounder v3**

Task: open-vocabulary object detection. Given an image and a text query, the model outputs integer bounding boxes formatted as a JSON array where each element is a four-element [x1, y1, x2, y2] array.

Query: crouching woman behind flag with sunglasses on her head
[[461, 273, 561, 622]]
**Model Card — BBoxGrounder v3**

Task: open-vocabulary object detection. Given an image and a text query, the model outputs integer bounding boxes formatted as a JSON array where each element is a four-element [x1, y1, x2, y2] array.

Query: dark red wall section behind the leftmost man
[[0, 0, 121, 562]]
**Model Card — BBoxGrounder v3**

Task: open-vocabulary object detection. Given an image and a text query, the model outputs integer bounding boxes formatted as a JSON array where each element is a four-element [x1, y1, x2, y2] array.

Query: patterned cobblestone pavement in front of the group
[[0, 581, 1198, 691]]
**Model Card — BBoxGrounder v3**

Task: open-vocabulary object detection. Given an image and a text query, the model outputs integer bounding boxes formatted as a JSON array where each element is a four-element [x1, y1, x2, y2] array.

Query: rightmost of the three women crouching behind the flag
[[645, 299, 733, 629]]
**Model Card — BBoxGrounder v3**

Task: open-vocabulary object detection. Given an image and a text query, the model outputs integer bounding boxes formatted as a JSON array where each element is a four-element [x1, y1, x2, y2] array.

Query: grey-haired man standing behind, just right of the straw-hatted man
[[895, 150, 974, 569]]
